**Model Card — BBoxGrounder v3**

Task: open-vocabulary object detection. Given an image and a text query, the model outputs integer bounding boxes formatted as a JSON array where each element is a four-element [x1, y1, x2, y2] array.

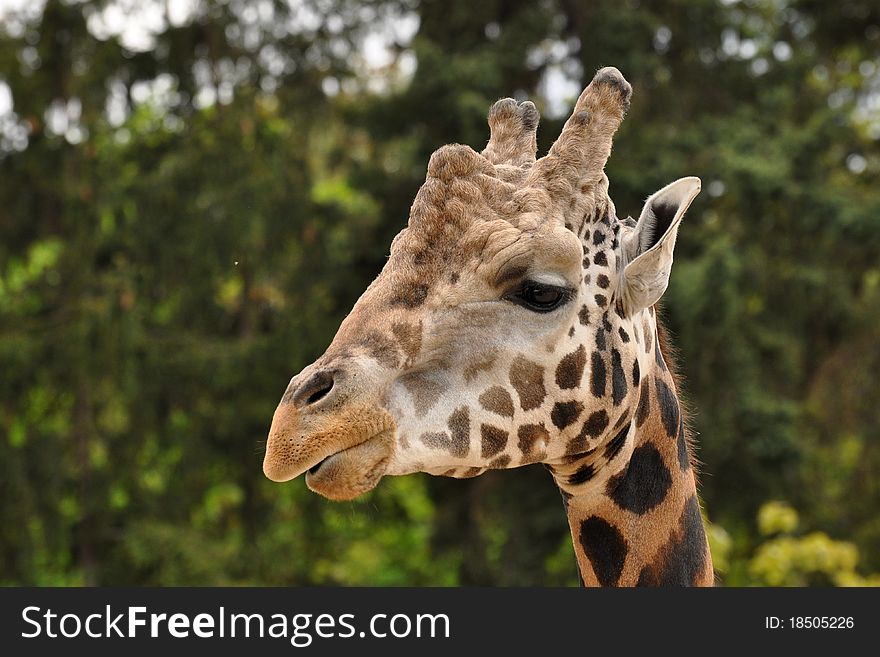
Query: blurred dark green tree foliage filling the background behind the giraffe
[[0, 0, 880, 585]]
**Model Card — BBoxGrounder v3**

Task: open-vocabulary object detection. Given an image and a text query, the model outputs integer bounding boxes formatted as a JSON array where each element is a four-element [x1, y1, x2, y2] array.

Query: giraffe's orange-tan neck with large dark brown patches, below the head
[[550, 328, 714, 586]]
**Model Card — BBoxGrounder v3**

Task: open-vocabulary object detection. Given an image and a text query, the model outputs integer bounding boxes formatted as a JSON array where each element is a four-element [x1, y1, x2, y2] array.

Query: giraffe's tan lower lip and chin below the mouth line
[[306, 428, 394, 500]]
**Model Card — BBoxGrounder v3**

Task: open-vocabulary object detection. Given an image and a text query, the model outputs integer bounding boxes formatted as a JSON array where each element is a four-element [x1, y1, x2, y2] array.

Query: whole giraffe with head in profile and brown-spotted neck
[[263, 67, 714, 586]]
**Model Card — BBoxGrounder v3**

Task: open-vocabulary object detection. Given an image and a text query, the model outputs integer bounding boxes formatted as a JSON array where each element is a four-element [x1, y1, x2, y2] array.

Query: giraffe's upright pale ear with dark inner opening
[[621, 176, 700, 315]]
